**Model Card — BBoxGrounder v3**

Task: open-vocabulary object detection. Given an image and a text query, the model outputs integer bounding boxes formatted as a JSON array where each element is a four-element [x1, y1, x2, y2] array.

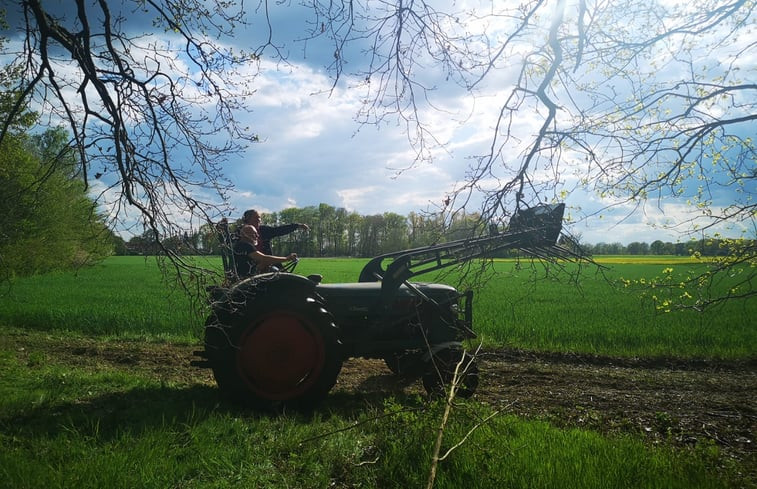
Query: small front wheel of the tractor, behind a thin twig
[[423, 348, 478, 398]]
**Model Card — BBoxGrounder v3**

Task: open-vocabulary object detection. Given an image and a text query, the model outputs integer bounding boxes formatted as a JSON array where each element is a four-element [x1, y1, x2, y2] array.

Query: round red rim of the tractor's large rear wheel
[[237, 311, 325, 400]]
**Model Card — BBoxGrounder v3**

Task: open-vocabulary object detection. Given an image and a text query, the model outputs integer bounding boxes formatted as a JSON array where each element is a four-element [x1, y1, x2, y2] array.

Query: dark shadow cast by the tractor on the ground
[[0, 374, 424, 441]]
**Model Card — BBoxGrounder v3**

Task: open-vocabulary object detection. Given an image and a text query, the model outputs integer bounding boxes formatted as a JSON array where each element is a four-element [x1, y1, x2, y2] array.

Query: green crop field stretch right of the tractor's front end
[[474, 263, 757, 359]]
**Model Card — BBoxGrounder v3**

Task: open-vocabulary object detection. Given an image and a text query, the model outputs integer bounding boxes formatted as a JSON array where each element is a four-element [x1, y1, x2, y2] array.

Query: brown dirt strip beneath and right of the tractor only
[[337, 351, 757, 464]]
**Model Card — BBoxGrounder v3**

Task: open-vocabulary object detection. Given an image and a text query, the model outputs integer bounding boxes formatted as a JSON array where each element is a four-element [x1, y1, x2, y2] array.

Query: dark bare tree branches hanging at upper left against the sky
[[0, 0, 257, 260]]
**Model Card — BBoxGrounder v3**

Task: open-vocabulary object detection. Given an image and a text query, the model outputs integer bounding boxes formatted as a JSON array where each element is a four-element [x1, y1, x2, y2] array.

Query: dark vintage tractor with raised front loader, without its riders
[[192, 204, 565, 409]]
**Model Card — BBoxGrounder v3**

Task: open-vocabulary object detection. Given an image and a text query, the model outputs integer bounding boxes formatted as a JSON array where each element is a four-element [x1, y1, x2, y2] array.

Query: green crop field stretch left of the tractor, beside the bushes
[[0, 257, 203, 341]]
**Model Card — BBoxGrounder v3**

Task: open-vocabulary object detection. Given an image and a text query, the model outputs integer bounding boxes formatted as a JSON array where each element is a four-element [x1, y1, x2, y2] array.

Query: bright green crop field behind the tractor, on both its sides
[[0, 257, 757, 359]]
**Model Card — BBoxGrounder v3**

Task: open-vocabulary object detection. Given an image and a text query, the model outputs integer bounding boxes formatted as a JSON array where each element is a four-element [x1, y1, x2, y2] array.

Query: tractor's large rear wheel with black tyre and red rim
[[205, 293, 342, 409]]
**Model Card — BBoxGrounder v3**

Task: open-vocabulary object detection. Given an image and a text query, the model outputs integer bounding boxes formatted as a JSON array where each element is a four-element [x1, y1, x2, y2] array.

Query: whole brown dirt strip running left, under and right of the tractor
[[7, 335, 757, 481]]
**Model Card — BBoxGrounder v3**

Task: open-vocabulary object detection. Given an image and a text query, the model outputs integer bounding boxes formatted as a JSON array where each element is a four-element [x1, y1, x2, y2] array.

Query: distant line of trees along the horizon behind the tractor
[[116, 204, 744, 258]]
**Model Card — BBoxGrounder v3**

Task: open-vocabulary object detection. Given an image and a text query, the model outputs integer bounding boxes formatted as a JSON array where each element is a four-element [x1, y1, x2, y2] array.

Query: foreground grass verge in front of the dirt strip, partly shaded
[[0, 340, 728, 489]]
